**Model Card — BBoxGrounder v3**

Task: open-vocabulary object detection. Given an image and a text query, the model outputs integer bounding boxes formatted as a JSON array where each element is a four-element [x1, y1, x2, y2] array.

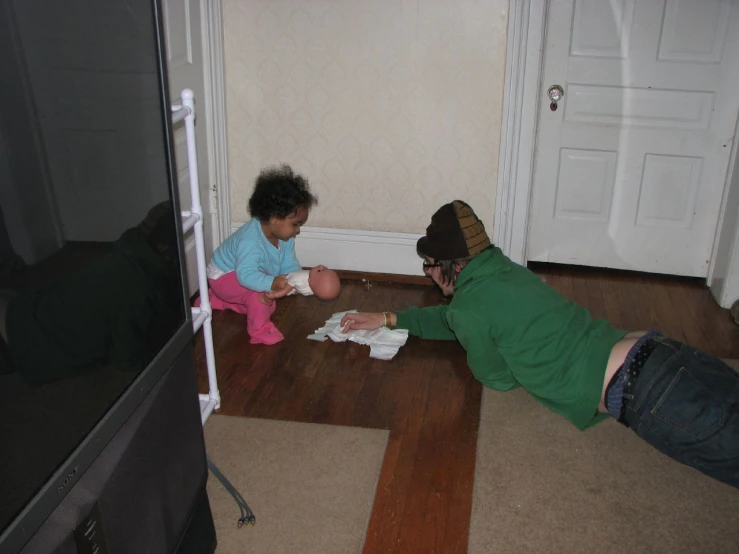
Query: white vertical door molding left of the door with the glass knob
[[493, 0, 546, 265]]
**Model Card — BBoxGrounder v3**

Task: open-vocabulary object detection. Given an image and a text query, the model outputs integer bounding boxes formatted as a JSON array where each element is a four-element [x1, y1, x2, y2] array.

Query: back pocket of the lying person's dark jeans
[[651, 367, 728, 444]]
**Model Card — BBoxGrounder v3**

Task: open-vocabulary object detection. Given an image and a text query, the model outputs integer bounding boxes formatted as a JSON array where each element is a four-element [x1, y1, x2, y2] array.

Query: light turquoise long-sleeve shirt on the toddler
[[213, 219, 302, 292]]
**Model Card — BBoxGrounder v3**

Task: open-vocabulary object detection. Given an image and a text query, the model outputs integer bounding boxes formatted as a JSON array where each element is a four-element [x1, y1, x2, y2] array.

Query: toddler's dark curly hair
[[249, 165, 318, 221]]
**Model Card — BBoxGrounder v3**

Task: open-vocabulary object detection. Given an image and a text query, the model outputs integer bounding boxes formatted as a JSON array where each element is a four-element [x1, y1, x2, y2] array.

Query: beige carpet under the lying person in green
[[469, 360, 739, 554]]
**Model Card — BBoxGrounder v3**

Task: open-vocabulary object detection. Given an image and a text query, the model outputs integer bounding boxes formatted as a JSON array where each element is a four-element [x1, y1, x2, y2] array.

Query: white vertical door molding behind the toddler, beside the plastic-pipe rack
[[200, 0, 231, 246]]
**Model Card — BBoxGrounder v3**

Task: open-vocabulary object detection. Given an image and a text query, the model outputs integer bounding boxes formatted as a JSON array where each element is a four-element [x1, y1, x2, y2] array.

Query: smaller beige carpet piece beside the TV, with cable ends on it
[[204, 415, 388, 554]]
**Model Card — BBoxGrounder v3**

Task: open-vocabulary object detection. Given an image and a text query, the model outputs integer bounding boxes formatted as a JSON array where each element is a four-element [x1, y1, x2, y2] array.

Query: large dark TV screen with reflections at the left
[[0, 0, 188, 535]]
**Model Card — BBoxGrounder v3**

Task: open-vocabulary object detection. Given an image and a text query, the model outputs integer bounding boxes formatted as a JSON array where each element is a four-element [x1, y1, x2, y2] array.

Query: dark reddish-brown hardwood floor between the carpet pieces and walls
[[196, 265, 739, 554]]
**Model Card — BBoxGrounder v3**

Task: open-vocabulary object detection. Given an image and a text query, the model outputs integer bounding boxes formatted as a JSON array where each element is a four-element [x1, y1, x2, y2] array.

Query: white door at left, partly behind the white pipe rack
[[162, 0, 216, 294]]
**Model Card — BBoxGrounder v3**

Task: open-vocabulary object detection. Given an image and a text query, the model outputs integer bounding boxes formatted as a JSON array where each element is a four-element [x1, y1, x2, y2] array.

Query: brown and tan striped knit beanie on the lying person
[[416, 200, 490, 260]]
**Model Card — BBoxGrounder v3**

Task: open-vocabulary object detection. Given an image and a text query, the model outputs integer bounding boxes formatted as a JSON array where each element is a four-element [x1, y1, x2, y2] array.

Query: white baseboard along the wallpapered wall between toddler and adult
[[231, 222, 423, 276]]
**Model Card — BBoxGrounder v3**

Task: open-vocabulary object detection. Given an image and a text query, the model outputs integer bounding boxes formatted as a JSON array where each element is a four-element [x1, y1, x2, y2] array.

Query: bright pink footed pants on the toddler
[[208, 271, 285, 344]]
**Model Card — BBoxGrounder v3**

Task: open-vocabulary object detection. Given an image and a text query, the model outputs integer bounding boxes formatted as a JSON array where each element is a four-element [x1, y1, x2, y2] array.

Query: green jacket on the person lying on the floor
[[396, 248, 626, 429]]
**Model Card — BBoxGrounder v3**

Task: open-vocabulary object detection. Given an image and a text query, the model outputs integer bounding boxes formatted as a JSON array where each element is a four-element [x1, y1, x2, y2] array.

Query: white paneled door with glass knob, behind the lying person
[[527, 0, 739, 277]]
